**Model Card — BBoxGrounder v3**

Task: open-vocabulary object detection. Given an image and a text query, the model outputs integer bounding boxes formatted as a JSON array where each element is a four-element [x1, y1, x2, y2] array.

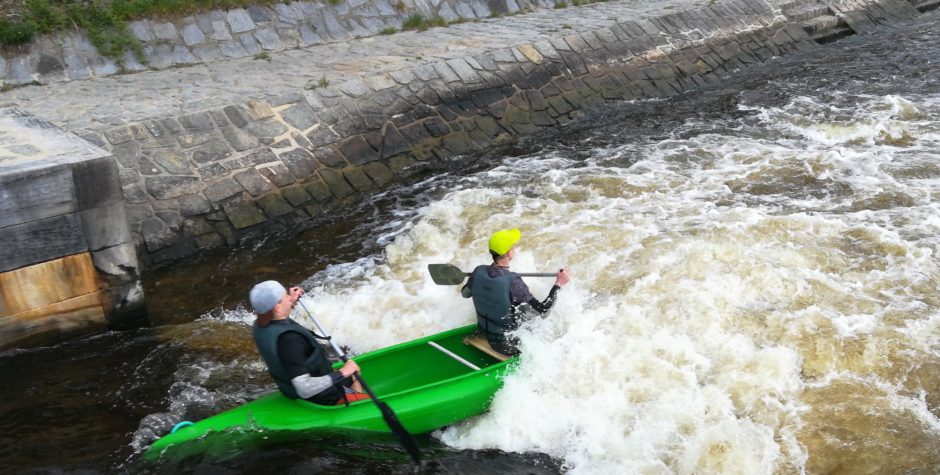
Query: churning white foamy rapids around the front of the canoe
[[149, 92, 940, 474]]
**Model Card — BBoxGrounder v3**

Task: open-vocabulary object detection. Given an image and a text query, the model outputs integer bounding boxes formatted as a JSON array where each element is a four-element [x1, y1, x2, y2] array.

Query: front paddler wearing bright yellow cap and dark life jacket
[[460, 228, 569, 356]]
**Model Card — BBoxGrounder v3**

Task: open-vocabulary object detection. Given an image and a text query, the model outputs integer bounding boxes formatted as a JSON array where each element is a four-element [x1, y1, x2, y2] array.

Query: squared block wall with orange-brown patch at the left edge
[[0, 107, 144, 349]]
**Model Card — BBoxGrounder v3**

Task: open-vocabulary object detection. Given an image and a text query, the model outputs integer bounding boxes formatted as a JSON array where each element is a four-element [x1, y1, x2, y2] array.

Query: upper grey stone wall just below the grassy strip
[[0, 0, 555, 86]]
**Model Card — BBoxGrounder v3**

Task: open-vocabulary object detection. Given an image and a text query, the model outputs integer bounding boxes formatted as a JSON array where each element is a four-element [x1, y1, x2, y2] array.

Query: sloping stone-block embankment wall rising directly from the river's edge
[[58, 0, 932, 263]]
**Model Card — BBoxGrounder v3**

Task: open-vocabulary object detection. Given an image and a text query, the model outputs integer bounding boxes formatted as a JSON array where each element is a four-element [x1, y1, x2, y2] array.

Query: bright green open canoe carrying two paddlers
[[143, 325, 516, 460]]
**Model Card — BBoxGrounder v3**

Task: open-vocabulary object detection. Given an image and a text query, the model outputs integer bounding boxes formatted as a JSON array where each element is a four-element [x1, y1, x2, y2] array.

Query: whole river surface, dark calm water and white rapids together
[[0, 11, 940, 474]]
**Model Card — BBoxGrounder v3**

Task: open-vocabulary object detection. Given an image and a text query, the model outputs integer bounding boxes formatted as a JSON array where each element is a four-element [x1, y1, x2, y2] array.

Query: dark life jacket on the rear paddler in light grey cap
[[252, 318, 343, 404]]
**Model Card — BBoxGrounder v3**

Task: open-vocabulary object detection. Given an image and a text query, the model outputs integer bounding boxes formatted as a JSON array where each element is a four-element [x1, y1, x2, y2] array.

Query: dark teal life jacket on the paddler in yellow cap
[[470, 265, 519, 341]]
